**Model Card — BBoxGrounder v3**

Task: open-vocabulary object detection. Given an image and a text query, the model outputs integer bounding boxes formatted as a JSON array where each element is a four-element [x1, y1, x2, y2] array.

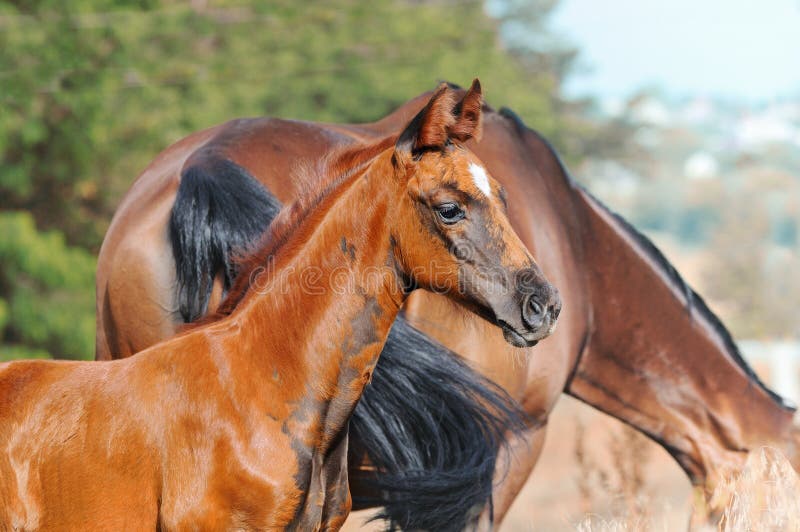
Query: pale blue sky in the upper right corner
[[552, 0, 800, 103]]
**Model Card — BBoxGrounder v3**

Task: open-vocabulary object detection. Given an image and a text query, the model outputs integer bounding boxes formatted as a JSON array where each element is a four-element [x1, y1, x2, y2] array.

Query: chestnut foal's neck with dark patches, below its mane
[[223, 150, 405, 451]]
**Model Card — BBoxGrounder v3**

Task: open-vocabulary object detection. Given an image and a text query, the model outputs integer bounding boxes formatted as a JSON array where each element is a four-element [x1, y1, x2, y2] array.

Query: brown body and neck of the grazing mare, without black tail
[[97, 86, 796, 519]]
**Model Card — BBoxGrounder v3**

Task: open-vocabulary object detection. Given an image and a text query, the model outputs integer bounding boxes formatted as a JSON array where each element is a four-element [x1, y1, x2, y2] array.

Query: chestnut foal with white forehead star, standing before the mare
[[0, 80, 559, 530]]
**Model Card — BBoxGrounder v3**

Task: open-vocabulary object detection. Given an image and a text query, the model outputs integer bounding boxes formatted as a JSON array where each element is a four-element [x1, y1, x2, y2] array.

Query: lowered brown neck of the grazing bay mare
[[568, 187, 797, 489]]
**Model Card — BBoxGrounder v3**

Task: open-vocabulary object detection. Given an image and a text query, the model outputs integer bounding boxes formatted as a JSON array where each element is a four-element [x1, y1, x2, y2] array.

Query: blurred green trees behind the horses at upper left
[[0, 0, 588, 357]]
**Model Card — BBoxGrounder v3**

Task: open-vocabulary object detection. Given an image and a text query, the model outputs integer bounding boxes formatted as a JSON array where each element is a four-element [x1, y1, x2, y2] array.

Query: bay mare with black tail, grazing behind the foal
[[97, 84, 798, 529]]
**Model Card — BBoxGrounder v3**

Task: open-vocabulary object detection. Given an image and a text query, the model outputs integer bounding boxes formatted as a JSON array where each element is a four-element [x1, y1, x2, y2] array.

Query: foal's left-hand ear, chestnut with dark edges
[[395, 83, 456, 156]]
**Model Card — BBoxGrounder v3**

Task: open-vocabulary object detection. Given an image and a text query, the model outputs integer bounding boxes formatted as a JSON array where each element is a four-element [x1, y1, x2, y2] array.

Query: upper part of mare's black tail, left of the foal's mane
[[169, 158, 281, 323]]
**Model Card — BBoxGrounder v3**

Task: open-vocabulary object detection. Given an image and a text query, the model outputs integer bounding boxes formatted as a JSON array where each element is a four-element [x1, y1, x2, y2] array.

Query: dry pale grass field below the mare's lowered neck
[[345, 396, 800, 532]]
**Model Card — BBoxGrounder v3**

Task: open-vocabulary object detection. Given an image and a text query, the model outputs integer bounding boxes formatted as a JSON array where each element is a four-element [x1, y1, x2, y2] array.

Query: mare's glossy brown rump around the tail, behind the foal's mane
[[95, 118, 368, 360]]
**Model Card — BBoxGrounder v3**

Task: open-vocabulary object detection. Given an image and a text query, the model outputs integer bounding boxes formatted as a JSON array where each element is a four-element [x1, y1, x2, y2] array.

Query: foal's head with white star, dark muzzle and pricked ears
[[392, 80, 561, 347]]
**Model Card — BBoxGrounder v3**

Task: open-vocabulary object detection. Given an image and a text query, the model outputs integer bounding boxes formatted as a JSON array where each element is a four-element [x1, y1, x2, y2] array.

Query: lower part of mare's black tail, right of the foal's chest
[[350, 315, 525, 531]]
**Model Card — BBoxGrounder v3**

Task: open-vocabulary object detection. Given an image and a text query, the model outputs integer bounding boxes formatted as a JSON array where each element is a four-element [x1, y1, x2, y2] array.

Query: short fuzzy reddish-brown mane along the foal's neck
[[200, 135, 397, 326]]
